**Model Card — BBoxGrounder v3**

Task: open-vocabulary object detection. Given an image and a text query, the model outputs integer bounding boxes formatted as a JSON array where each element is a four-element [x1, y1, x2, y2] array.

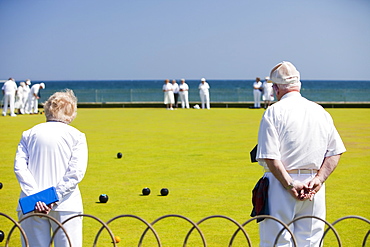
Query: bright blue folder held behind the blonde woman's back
[[19, 187, 59, 214]]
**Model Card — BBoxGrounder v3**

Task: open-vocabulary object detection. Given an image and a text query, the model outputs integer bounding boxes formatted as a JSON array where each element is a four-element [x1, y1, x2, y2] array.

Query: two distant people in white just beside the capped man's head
[[253, 76, 274, 109]]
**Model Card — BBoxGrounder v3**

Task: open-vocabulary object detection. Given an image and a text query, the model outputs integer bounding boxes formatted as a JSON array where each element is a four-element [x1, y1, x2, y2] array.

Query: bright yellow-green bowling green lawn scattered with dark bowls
[[0, 108, 370, 247]]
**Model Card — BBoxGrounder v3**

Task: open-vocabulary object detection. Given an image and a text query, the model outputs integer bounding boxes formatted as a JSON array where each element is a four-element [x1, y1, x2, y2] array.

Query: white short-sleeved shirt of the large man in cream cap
[[257, 92, 346, 170]]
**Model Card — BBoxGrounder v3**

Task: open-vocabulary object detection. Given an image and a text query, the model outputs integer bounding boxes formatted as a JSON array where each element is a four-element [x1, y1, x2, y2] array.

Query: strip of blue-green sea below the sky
[[0, 80, 370, 103]]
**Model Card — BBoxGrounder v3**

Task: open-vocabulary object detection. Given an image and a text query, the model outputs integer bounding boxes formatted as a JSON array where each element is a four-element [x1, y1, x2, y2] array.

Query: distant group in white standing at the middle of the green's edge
[[162, 78, 211, 110]]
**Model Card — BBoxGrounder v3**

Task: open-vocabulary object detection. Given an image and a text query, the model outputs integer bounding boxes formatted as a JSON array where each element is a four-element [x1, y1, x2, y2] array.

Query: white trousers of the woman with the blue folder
[[18, 211, 82, 247]]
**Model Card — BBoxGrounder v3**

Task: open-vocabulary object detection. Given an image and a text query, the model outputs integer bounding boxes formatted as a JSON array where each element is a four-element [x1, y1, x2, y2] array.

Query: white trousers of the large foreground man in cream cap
[[259, 172, 326, 247]]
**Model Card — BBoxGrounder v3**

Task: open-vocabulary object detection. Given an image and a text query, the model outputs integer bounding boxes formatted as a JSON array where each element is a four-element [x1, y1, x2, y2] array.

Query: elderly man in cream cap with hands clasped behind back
[[257, 62, 346, 247]]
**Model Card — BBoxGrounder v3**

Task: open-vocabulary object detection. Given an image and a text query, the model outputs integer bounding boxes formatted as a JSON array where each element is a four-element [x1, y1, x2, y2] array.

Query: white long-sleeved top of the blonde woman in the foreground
[[14, 122, 88, 212]]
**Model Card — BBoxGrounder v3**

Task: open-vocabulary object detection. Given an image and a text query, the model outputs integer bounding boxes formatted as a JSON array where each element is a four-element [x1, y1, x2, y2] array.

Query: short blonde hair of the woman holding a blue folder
[[44, 89, 77, 124]]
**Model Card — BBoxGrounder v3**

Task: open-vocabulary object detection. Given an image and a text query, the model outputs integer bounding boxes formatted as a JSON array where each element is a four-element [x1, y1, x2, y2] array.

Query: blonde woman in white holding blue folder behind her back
[[14, 89, 88, 247]]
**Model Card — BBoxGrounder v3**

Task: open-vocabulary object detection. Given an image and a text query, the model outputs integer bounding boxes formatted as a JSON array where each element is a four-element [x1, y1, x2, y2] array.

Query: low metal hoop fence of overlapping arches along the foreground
[[0, 212, 370, 247]]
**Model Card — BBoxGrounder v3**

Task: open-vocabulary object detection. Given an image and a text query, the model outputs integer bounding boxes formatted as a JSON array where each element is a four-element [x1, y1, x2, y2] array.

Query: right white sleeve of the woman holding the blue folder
[[56, 133, 88, 204]]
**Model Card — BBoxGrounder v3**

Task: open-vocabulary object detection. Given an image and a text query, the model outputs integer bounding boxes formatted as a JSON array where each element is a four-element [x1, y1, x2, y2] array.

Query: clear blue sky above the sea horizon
[[0, 0, 370, 81]]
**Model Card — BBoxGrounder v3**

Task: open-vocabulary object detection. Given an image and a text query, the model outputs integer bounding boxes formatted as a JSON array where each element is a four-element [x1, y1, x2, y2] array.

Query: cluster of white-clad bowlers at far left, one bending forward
[[2, 78, 45, 117]]
